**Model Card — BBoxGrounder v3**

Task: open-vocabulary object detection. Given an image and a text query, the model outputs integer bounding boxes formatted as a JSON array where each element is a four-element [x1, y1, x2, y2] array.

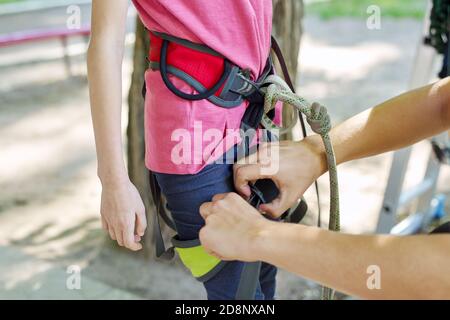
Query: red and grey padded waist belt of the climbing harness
[[149, 31, 273, 108]]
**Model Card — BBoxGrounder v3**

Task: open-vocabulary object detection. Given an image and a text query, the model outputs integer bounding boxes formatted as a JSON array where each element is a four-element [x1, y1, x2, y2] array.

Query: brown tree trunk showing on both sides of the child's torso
[[127, 0, 303, 257]]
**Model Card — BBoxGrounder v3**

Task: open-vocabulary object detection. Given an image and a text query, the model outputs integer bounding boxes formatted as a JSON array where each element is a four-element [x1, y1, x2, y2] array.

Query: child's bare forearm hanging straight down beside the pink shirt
[[88, 42, 126, 181]]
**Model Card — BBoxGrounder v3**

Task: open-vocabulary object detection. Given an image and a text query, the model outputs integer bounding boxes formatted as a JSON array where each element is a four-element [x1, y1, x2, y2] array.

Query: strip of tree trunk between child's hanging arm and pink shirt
[[127, 19, 154, 257]]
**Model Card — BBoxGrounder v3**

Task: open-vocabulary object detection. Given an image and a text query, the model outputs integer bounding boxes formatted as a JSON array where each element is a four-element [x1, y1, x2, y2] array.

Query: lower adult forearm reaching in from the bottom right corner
[[253, 223, 450, 299]]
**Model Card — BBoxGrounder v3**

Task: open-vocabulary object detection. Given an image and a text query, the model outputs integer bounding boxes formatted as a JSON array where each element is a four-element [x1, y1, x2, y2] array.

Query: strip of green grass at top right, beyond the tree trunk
[[305, 0, 427, 19]]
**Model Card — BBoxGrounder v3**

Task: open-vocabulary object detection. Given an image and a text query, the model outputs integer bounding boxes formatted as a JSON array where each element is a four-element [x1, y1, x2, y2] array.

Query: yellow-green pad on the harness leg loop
[[175, 246, 220, 278]]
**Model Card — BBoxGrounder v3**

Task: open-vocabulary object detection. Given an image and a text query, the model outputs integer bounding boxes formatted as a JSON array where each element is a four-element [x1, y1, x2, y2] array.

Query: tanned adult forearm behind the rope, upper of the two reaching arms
[[309, 78, 450, 169]]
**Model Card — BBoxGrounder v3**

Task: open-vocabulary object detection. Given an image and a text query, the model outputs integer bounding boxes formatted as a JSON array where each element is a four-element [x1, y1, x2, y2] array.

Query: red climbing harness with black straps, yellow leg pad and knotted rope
[[143, 31, 340, 300]]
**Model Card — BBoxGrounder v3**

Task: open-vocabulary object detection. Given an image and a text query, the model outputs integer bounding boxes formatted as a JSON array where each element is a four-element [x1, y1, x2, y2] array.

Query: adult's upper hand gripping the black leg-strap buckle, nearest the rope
[[234, 135, 327, 218]]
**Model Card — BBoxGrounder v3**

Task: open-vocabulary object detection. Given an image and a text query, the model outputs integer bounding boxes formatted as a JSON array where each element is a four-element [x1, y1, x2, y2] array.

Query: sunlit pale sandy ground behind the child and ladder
[[0, 17, 450, 299]]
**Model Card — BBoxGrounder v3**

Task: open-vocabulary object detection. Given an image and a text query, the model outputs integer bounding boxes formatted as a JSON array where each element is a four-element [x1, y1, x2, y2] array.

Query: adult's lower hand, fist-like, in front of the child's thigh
[[199, 193, 268, 261]]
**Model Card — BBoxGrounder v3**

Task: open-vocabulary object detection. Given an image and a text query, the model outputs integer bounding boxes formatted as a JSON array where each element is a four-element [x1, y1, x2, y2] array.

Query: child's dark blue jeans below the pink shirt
[[154, 164, 277, 300]]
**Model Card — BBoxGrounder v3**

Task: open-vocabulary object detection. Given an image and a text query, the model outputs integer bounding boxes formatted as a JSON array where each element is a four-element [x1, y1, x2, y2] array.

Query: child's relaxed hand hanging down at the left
[[100, 179, 147, 251]]
